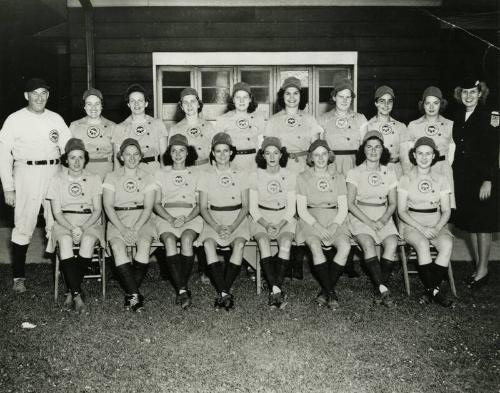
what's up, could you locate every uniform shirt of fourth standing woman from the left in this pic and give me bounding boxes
[214,110,267,150]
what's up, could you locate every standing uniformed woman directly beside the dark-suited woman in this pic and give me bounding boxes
[401,86,456,209]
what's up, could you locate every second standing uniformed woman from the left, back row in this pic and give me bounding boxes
[112,84,168,175]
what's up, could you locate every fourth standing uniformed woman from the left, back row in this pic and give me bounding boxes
[215,82,267,171]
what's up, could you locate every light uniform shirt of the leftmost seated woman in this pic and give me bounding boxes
[46,168,102,211]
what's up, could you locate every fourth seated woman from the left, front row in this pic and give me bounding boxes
[198,132,250,310]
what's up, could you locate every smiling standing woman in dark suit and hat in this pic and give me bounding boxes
[453,77,500,289]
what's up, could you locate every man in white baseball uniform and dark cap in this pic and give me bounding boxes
[0,78,71,293]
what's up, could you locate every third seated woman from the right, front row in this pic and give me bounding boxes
[295,140,351,309]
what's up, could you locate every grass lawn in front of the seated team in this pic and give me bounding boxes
[0,263,500,393]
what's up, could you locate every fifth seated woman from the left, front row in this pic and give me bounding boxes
[250,136,296,308]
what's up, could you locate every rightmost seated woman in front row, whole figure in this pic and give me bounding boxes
[398,137,453,307]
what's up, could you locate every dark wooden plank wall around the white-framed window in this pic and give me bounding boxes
[69,7,440,121]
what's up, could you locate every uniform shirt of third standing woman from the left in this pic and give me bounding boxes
[169,117,215,160]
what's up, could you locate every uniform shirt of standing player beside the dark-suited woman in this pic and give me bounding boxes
[402,115,453,158]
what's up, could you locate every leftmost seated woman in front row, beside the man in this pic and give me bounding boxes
[47,138,104,314]
